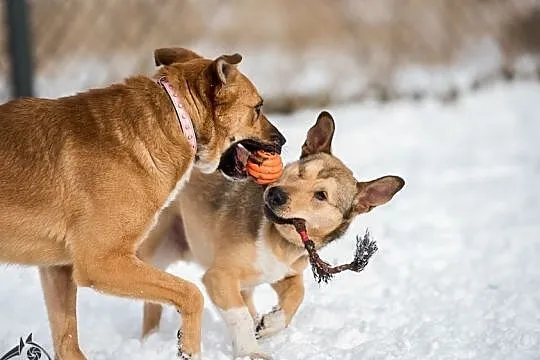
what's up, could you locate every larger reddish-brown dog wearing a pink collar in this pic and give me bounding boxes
[0,48,285,360]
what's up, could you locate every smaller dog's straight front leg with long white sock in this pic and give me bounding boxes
[203,267,270,359]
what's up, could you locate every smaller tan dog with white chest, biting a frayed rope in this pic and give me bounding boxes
[140,112,404,358]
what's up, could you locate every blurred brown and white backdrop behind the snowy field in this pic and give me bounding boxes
[0,0,540,112]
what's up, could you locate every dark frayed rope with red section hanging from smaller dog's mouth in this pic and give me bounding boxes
[292,219,378,284]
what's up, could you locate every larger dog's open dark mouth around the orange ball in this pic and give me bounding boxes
[218,139,281,179]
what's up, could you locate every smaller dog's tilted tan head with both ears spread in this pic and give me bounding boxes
[264,112,405,247]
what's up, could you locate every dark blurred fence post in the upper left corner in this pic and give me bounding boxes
[5,0,34,97]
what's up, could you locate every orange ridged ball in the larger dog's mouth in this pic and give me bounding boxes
[237,144,283,185]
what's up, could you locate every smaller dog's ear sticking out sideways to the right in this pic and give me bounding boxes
[353,176,405,214]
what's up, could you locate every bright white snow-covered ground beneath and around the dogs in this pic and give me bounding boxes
[0,83,540,360]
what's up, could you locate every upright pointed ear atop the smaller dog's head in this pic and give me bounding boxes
[300,111,335,159]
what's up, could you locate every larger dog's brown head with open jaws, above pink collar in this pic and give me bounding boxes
[154,48,285,178]
